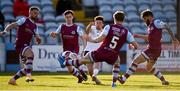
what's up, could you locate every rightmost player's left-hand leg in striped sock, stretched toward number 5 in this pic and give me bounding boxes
[119,54,146,84]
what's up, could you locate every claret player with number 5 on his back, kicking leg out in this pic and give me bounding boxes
[59,11,137,86]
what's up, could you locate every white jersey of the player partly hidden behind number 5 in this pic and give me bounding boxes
[84,26,102,51]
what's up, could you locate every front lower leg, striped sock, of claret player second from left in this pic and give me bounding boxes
[66,66,83,83]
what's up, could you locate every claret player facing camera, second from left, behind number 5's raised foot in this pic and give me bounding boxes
[50,10,87,83]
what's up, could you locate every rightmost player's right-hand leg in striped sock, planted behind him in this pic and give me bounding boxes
[146,60,169,85]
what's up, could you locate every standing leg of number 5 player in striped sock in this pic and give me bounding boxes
[112,57,120,87]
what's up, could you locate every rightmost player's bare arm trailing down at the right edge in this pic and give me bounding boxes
[165,24,180,49]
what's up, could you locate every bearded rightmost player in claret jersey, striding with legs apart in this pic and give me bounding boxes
[120,9,179,85]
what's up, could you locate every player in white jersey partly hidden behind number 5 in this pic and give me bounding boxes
[84,16,104,84]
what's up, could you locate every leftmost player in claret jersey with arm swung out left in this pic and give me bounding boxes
[0,6,41,85]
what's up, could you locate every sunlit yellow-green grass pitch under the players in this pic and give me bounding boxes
[0,72,180,91]
